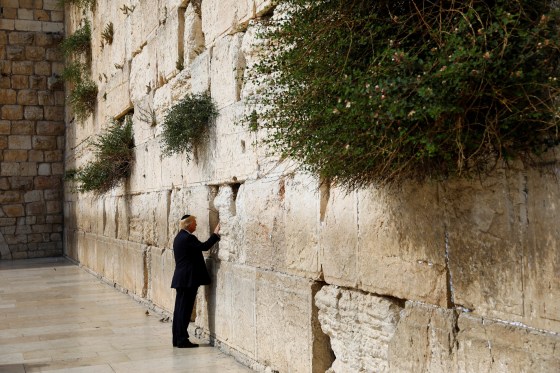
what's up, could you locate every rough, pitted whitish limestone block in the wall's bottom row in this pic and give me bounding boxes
[315,285,402,373]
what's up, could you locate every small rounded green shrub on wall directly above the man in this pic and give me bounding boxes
[160,93,218,161]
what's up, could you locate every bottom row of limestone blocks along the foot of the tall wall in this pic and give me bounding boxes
[66,231,560,373]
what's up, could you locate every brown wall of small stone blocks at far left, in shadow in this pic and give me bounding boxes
[0,0,65,259]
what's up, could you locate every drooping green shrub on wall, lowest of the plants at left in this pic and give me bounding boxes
[65,116,134,194]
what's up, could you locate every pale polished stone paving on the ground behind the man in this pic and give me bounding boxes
[0,258,251,373]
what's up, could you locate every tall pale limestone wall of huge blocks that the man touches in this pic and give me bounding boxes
[64,0,560,372]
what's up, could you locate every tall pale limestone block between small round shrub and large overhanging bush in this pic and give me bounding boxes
[210,33,245,109]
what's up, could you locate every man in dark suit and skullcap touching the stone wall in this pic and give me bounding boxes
[171,215,220,348]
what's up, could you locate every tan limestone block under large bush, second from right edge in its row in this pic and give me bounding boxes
[443,171,527,319]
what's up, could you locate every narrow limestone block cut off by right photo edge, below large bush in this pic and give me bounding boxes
[518,170,560,333]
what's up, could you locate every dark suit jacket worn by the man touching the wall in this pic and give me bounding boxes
[171,230,220,289]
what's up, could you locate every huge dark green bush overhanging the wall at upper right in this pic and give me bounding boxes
[246,0,560,190]
